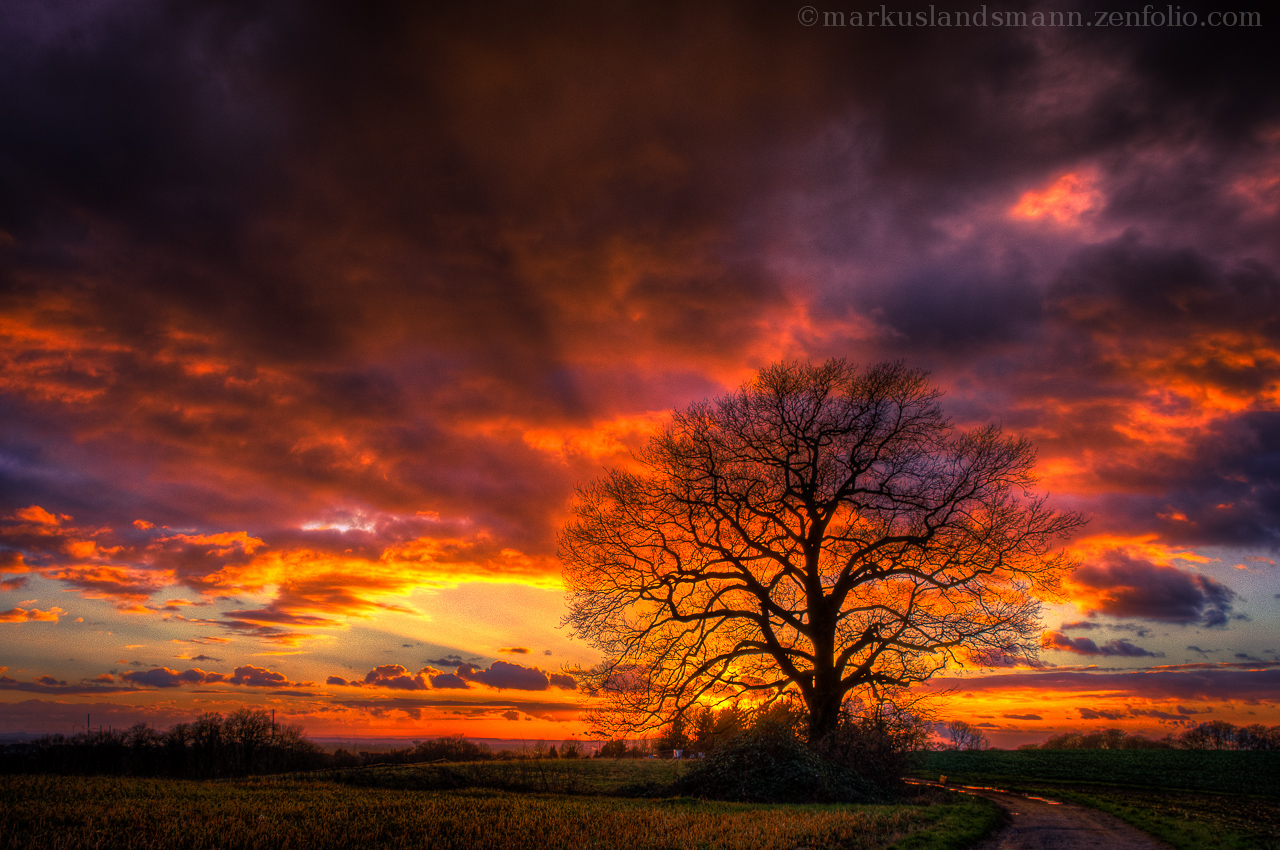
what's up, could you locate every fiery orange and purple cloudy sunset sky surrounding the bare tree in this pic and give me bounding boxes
[0,0,1280,745]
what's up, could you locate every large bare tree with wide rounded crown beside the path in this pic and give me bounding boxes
[561,360,1082,741]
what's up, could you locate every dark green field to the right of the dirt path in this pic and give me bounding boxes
[913,750,1280,850]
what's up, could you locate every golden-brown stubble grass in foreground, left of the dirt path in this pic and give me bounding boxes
[0,776,998,850]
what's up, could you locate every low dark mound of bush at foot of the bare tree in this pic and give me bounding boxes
[663,726,891,803]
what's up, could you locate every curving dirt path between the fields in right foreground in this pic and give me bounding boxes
[955,789,1169,850]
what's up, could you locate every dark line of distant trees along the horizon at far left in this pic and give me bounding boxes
[0,708,329,778]
